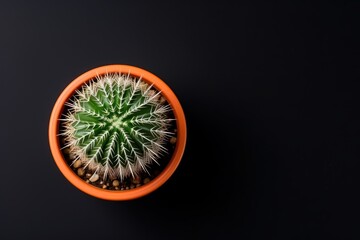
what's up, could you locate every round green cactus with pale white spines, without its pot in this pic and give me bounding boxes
[60,73,174,180]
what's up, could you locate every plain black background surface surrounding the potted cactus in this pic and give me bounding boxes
[0,1,360,240]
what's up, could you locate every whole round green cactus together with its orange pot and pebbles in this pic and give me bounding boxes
[49,65,186,200]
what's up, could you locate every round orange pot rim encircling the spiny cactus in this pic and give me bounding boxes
[49,65,186,201]
